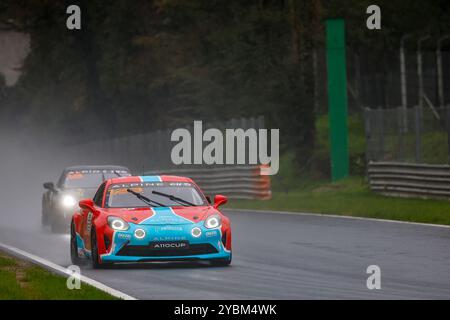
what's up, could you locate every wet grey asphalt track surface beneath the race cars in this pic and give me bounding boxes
[0,210,450,299]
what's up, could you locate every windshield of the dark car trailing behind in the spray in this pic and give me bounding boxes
[63,170,130,189]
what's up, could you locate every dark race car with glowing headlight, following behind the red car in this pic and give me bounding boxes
[41,166,131,232]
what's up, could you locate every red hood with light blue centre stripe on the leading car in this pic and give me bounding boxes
[104,206,218,225]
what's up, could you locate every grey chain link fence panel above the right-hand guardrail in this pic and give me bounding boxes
[364,106,450,164]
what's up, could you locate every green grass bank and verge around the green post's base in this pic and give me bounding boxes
[239,115,450,225]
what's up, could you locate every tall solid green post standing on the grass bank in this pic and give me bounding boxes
[326,19,348,181]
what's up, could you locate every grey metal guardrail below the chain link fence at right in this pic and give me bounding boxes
[368,162,450,200]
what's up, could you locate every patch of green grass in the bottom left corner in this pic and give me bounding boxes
[0,252,115,300]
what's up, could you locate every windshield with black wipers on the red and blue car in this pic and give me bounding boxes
[106,182,206,208]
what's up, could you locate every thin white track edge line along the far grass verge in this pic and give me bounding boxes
[224,208,450,229]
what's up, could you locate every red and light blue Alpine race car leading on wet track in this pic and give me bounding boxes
[70,176,231,268]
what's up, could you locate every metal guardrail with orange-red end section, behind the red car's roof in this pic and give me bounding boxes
[145,166,272,199]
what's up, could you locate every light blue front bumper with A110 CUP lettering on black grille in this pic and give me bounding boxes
[100,222,231,263]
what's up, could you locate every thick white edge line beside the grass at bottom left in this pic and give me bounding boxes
[0,243,137,300]
